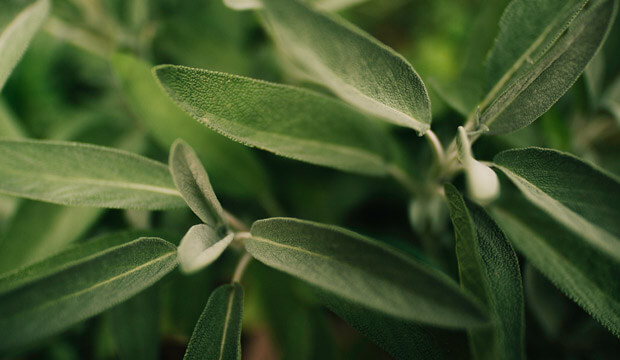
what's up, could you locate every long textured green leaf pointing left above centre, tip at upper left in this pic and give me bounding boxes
[155,65,398,175]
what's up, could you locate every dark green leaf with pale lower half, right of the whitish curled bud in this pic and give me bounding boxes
[494,148,620,260]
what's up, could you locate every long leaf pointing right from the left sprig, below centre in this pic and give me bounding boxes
[246,218,488,328]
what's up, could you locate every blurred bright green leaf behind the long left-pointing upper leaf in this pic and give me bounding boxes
[112,54,269,196]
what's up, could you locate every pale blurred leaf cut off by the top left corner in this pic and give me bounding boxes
[0,0,50,90]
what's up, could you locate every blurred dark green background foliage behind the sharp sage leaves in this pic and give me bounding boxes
[0,0,620,360]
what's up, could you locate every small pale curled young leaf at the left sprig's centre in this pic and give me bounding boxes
[178,224,235,273]
